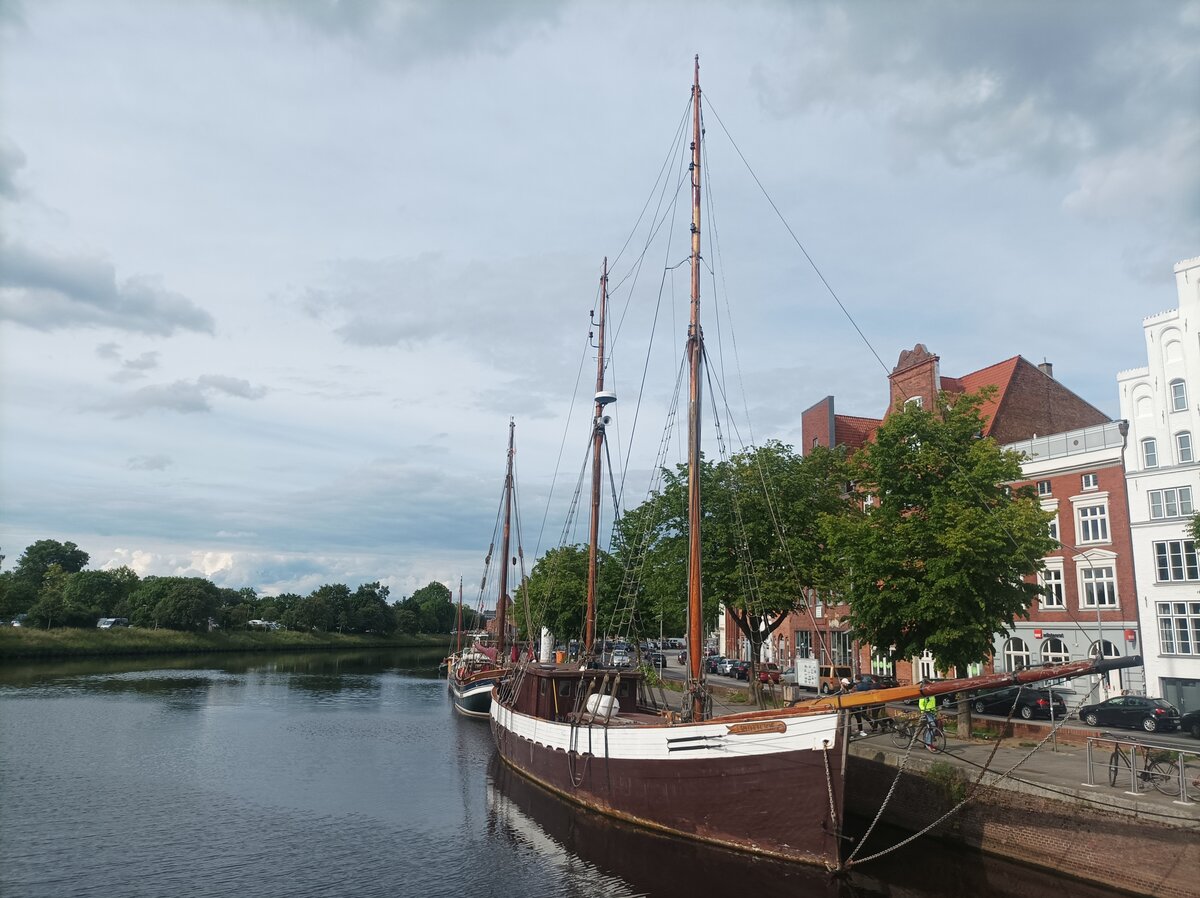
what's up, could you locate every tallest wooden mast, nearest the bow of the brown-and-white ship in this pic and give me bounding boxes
[688,55,704,720]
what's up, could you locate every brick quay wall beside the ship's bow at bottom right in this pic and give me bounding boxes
[846,747,1200,898]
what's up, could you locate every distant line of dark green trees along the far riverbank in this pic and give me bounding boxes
[0,547,482,635]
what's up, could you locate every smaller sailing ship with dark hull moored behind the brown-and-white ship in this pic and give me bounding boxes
[446,419,516,719]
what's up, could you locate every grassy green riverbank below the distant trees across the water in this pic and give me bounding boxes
[0,627,452,661]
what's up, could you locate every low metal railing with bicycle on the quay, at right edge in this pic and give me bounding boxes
[1085,732,1200,804]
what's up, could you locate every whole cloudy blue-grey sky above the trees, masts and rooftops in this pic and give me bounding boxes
[0,0,1200,598]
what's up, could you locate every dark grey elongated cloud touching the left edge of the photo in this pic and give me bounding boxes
[0,241,214,336]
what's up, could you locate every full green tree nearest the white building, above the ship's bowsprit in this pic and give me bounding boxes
[824,394,1056,725]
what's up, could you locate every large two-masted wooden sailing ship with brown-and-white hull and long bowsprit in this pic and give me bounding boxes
[491,58,1134,868]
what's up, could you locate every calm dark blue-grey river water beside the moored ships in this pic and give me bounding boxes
[0,651,1114,898]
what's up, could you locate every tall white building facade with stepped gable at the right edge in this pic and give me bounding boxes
[1117,258,1200,711]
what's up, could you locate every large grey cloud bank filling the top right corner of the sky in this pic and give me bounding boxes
[756,0,1200,221]
